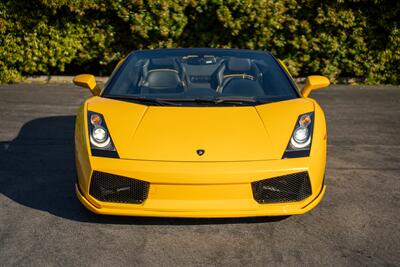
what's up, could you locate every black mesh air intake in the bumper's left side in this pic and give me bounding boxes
[89,171,149,204]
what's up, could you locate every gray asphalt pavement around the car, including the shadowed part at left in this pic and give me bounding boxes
[0,84,400,266]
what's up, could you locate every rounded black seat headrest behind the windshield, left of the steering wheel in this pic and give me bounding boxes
[144,69,180,89]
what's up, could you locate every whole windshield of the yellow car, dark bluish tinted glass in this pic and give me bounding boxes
[103,49,298,105]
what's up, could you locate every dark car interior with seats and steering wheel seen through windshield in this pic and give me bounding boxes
[113,55,290,98]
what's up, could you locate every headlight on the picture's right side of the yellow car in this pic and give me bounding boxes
[282,112,314,158]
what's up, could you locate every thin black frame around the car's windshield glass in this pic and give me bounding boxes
[99,48,301,106]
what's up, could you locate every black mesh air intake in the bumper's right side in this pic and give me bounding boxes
[251,172,311,203]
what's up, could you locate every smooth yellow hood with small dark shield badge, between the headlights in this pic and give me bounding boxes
[87,97,314,162]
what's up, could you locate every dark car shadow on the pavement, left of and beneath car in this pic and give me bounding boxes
[0,116,287,225]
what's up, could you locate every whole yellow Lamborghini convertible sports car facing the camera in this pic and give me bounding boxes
[74,48,329,217]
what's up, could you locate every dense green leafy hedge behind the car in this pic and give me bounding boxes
[0,0,400,84]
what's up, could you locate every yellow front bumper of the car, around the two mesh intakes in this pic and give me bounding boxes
[76,155,326,218]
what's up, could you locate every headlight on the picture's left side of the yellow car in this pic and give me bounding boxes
[88,111,119,158]
